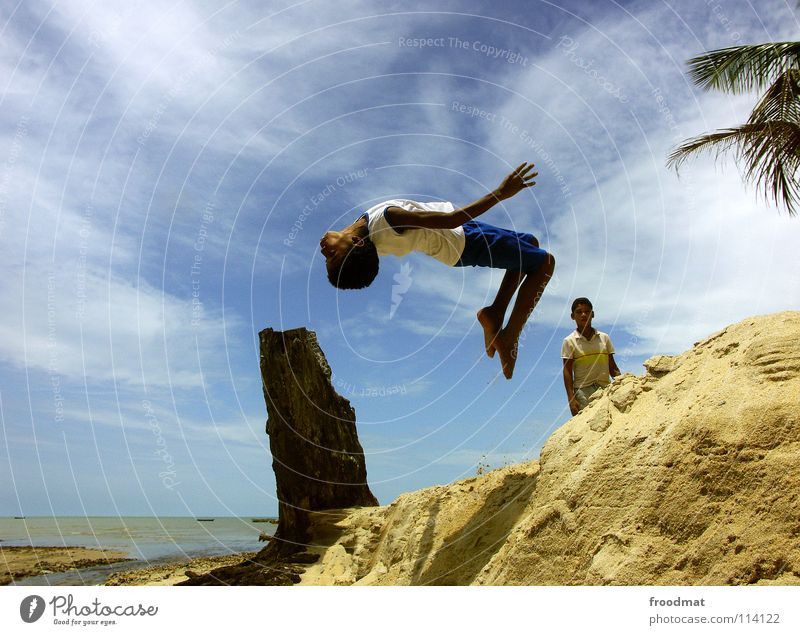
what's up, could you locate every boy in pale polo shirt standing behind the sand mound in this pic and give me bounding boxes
[561,298,620,415]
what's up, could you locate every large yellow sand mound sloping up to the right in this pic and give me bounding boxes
[302,312,800,585]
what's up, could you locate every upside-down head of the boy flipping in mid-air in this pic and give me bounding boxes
[319,228,379,289]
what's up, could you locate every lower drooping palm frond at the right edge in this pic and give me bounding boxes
[667,121,800,216]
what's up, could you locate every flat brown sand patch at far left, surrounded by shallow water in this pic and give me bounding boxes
[0,545,134,586]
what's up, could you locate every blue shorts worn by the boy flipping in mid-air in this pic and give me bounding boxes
[453,220,547,273]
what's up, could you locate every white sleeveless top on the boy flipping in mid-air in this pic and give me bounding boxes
[367,199,464,267]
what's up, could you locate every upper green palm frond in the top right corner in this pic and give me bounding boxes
[689,42,800,93]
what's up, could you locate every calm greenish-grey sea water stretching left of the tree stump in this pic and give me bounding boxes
[0,516,276,585]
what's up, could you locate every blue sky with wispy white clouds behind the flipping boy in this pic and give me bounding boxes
[0,0,800,515]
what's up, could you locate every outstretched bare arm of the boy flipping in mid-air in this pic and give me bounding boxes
[386,161,539,231]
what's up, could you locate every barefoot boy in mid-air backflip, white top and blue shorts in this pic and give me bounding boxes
[319,162,555,379]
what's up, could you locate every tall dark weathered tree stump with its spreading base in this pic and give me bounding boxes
[181,328,378,585]
